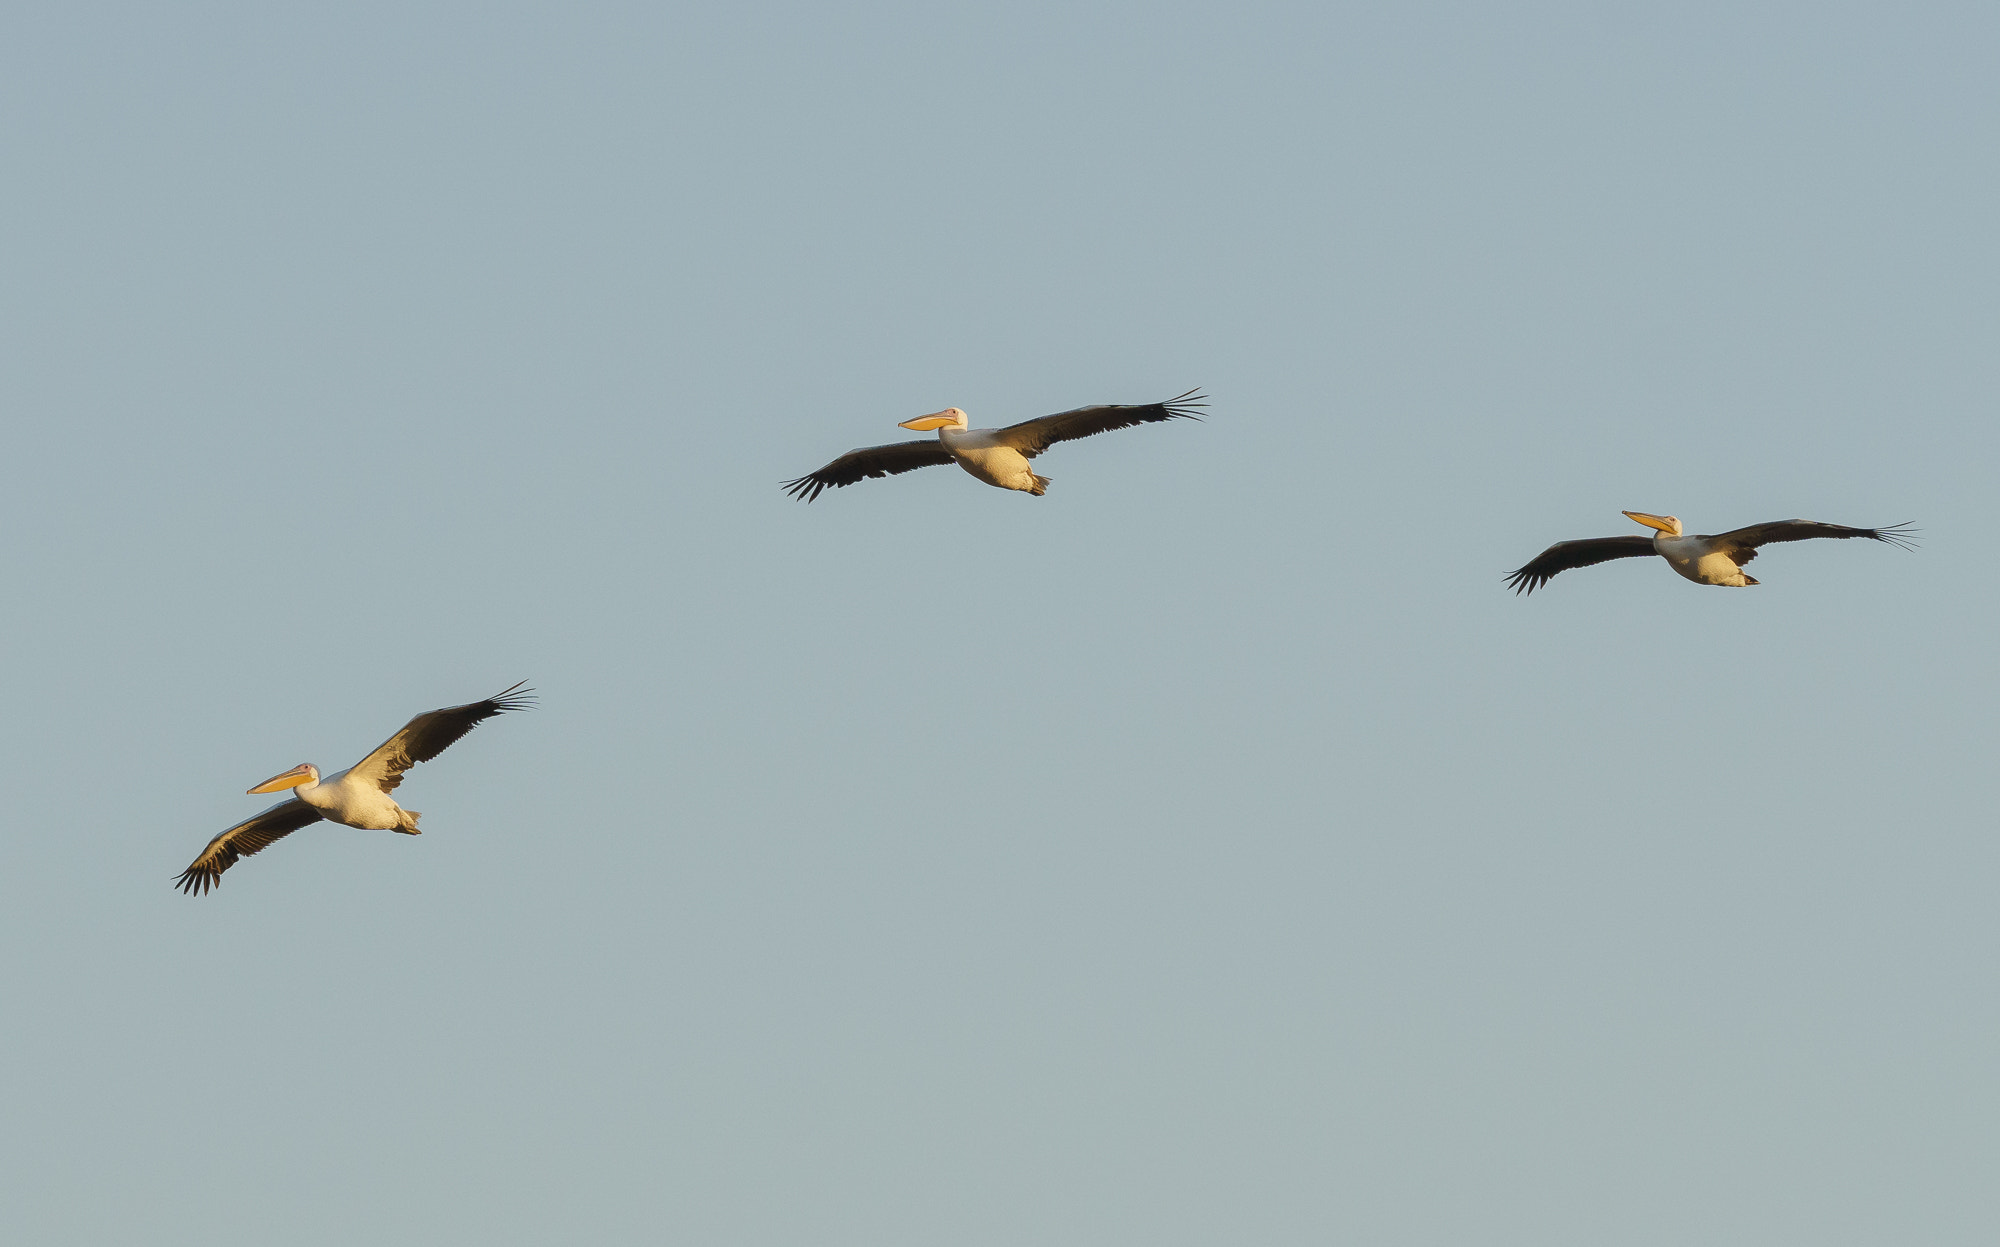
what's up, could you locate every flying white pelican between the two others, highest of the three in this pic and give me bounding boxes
[784,390,1208,502]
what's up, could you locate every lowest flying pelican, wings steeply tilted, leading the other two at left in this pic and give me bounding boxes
[176,679,534,895]
